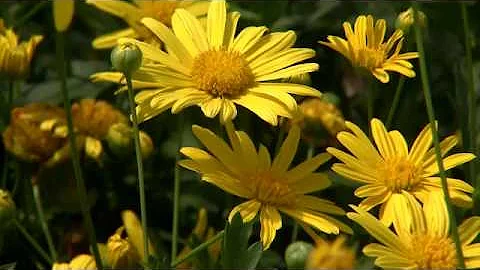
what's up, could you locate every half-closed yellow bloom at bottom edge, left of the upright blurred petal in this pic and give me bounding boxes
[107,226,140,269]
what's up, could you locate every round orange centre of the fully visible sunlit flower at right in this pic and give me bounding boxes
[379,157,422,192]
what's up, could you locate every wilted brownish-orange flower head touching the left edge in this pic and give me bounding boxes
[3,103,65,163]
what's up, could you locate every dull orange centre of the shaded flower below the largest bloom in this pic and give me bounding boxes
[250,172,295,206]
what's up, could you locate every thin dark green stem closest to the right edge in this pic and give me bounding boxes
[460,2,478,189]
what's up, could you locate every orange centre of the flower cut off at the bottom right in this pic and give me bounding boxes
[410,234,457,269]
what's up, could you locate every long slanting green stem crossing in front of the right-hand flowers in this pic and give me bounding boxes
[412,1,465,269]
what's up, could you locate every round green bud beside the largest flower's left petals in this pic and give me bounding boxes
[110,43,143,76]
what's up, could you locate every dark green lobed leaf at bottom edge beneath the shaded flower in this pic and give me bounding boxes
[221,213,263,269]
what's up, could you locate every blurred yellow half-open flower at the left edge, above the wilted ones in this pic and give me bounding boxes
[0,19,43,79]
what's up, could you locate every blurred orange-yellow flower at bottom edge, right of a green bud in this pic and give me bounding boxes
[305,236,356,269]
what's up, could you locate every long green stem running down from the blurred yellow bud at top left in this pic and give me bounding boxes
[56,32,103,270]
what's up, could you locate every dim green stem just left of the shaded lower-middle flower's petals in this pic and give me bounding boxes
[170,115,183,262]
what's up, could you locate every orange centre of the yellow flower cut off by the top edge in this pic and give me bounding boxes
[137,1,179,27]
